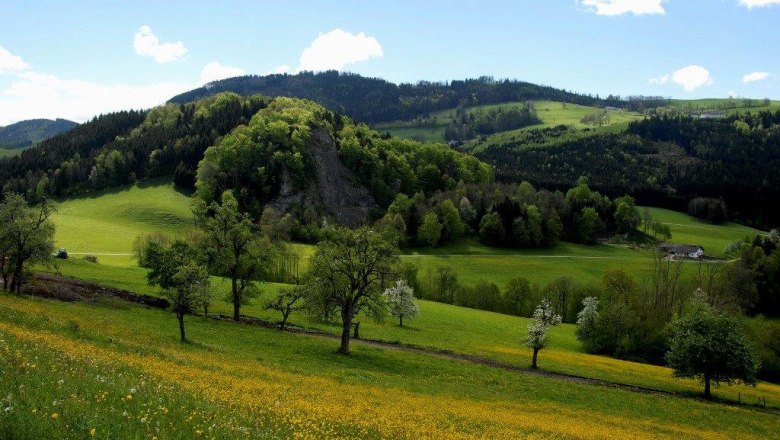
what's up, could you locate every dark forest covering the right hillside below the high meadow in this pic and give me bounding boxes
[474,112,780,228]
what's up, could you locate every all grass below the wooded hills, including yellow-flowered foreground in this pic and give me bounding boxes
[10,182,780,438]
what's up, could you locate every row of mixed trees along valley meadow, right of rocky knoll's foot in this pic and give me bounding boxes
[378,178,641,248]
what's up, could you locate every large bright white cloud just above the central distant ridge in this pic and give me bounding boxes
[298,29,384,71]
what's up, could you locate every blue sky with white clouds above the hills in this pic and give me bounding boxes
[0,0,780,125]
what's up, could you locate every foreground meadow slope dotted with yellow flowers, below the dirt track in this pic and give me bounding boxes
[0,294,780,439]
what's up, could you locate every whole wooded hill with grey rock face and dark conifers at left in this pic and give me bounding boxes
[0,93,493,225]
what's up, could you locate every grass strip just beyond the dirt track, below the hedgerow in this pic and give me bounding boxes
[50,260,780,408]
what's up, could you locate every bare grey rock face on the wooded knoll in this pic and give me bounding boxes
[271,129,377,227]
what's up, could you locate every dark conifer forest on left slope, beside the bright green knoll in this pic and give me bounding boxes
[0,94,268,201]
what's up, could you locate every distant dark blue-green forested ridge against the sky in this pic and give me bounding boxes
[170,71,665,123]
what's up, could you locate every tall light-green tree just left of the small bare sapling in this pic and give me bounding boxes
[193,191,271,321]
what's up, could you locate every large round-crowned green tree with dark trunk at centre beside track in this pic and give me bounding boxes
[307,227,399,354]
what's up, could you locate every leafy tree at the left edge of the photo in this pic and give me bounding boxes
[0,193,57,293]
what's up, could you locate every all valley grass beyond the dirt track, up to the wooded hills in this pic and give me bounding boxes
[42,182,780,405]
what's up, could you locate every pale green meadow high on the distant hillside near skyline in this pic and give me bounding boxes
[375,101,641,142]
